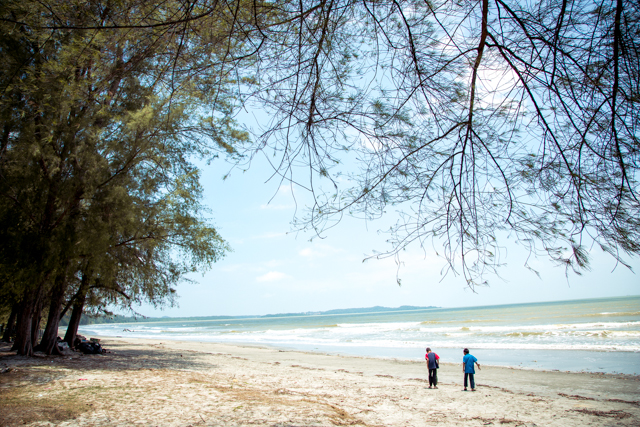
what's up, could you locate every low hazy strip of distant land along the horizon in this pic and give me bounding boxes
[67,305,440,326]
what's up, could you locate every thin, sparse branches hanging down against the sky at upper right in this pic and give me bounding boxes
[238,0,640,286]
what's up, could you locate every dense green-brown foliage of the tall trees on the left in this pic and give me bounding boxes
[0,0,247,346]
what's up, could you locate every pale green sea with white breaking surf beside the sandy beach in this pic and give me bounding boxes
[80,296,640,375]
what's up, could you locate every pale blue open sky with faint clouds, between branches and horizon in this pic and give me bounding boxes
[138,149,640,317]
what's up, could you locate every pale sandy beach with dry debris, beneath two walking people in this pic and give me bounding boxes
[0,338,640,427]
